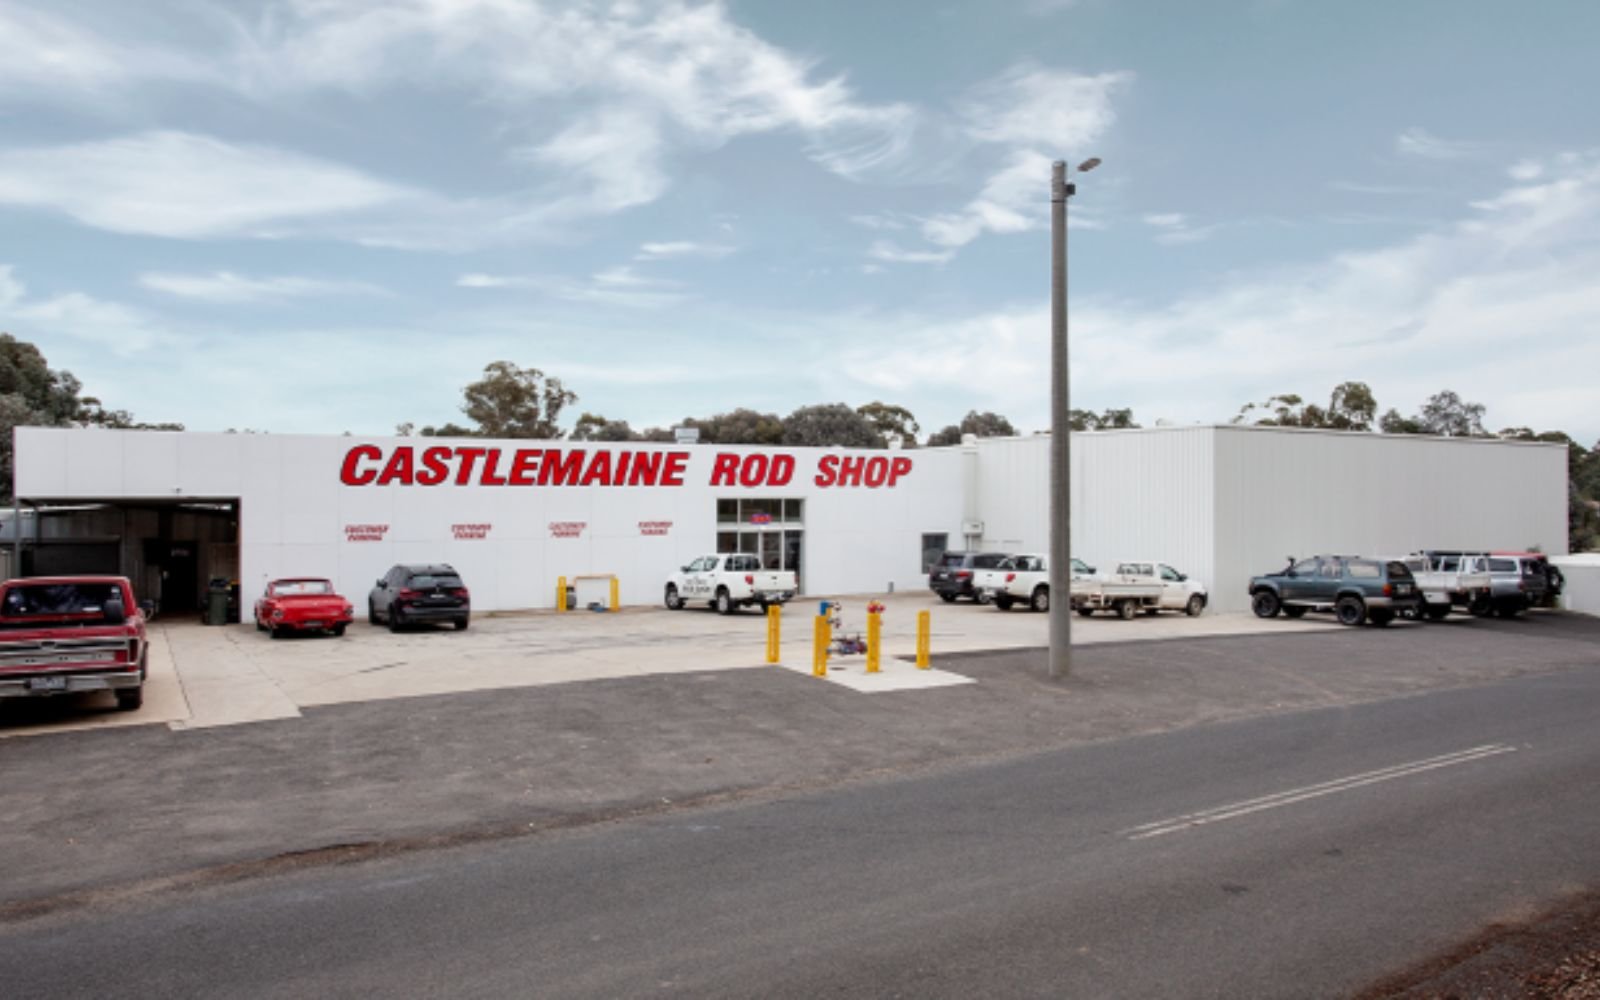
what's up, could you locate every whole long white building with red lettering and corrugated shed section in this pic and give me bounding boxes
[5,426,1566,611]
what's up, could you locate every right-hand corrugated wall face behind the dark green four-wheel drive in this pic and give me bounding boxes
[1213,427,1566,610]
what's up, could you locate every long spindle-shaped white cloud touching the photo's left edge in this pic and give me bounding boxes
[0,131,414,238]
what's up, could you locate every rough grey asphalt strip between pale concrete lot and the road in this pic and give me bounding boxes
[0,613,1600,920]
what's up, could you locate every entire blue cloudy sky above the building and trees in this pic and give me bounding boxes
[0,0,1600,443]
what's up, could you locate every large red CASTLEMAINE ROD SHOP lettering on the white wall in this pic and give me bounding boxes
[339,445,912,490]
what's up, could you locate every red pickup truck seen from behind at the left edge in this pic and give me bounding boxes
[0,576,149,712]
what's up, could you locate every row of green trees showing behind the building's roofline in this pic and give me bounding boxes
[0,333,1600,550]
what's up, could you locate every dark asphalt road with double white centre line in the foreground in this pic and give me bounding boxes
[9,667,1600,998]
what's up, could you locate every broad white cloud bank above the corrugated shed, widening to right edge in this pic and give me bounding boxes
[829,157,1600,440]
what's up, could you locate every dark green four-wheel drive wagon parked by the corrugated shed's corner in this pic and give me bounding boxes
[1250,555,1422,626]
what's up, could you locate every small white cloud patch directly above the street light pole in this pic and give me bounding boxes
[960,66,1133,148]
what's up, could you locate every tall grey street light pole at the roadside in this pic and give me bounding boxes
[1050,158,1099,680]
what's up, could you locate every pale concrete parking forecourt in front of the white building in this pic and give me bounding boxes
[0,594,1337,738]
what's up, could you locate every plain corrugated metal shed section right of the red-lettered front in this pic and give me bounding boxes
[978,426,1566,611]
